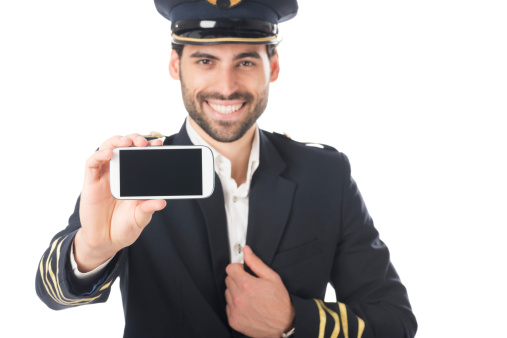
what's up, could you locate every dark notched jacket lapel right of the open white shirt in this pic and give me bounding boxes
[246,132,296,265]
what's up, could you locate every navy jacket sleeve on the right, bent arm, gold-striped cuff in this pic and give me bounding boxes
[292,155,417,338]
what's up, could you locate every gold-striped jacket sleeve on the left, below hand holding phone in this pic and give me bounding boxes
[35,199,124,310]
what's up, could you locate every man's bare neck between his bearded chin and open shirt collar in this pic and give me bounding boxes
[188,116,256,186]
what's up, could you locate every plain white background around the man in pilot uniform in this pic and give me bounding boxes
[0,0,507,337]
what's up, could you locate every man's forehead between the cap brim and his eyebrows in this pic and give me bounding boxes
[182,44,267,59]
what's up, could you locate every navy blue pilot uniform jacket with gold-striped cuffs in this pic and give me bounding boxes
[36,127,417,338]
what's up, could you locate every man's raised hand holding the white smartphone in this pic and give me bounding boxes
[74,134,166,272]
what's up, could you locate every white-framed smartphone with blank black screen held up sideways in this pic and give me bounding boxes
[110,146,215,200]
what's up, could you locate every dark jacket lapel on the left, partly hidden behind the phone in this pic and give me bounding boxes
[164,124,231,309]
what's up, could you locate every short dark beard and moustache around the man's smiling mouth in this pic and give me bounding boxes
[180,72,269,142]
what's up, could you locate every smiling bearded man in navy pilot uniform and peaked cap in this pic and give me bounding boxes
[36,0,417,338]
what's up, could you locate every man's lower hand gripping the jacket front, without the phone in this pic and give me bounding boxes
[225,246,295,338]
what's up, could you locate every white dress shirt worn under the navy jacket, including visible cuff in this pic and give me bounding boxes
[70,118,260,279]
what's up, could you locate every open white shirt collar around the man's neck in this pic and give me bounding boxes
[185,118,260,185]
